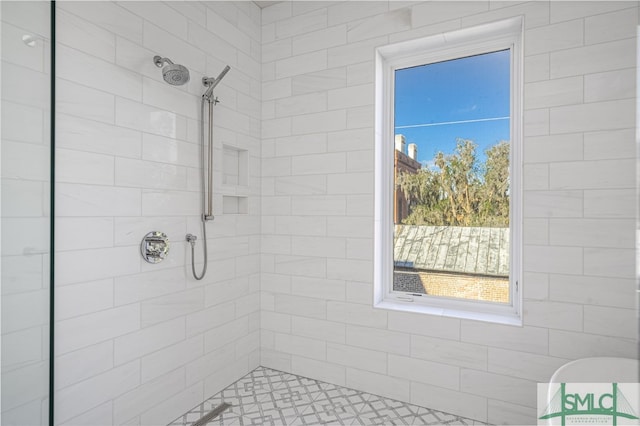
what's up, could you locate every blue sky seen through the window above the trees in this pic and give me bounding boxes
[395,50,510,163]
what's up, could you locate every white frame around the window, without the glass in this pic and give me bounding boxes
[373,17,524,325]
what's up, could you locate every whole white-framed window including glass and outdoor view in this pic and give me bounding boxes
[374,18,522,324]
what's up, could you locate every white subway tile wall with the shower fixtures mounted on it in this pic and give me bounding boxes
[53,1,260,425]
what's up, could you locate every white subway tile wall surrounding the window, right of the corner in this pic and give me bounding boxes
[261,1,638,424]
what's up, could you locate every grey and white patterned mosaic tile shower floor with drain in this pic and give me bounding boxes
[169,367,486,426]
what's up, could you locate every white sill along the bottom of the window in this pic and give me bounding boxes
[373,300,522,326]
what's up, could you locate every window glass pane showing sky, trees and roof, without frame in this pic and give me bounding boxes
[393,50,511,303]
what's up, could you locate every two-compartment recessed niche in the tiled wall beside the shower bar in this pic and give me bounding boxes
[222,145,249,214]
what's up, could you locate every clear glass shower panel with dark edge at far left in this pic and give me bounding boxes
[0,1,51,426]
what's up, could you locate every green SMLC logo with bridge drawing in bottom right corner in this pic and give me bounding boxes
[538,383,638,426]
